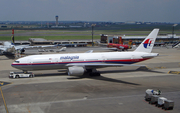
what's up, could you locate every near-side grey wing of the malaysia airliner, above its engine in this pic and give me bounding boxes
[66,63,144,68]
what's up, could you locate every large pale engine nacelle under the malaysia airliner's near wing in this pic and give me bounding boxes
[68,66,85,76]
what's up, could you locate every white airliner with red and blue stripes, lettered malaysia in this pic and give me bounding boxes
[11,29,159,76]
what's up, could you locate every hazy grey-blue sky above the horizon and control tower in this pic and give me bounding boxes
[0,0,180,23]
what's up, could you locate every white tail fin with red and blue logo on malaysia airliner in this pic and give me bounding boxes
[134,29,159,53]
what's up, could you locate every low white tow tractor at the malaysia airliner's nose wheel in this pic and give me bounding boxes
[9,72,34,78]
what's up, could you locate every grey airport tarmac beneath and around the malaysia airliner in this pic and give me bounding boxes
[0,47,180,113]
